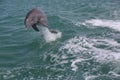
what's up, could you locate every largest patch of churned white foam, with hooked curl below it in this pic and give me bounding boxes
[60,37,120,71]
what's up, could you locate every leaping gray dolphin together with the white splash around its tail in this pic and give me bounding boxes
[24,8,61,42]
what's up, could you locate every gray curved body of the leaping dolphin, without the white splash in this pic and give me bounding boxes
[24,8,48,31]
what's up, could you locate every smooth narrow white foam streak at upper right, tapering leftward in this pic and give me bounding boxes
[75,19,120,31]
